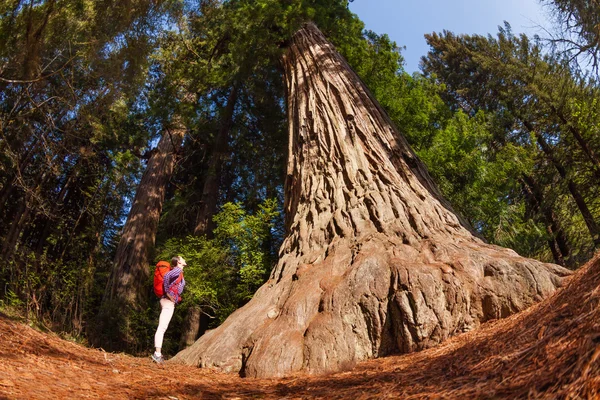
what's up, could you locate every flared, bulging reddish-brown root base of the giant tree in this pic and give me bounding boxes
[173,234,571,377]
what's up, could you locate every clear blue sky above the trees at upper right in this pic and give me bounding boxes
[350,0,550,73]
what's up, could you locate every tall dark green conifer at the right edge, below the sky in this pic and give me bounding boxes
[423,27,600,264]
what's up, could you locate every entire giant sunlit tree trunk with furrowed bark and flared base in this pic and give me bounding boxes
[173,24,569,377]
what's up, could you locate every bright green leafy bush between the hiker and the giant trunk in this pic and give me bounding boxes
[157,200,279,323]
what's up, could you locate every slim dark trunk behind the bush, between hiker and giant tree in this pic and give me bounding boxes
[179,84,239,349]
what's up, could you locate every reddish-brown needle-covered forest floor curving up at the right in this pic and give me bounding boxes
[0,256,600,400]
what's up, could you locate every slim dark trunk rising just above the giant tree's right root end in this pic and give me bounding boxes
[521,175,571,266]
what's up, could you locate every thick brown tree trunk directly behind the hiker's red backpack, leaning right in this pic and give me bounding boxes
[93,120,185,351]
